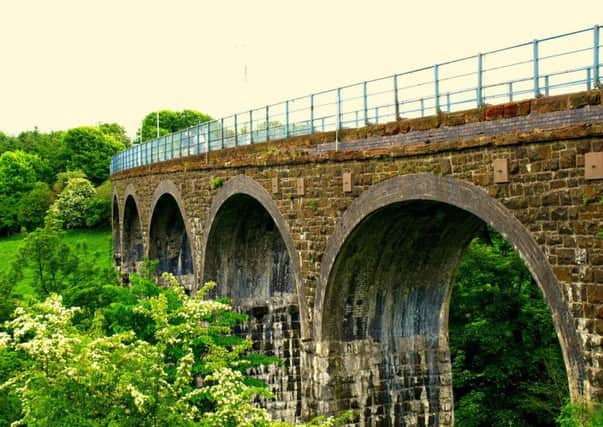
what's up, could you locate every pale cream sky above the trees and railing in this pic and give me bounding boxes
[0,0,603,135]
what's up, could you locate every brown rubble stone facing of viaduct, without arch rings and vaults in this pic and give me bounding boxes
[112,90,603,425]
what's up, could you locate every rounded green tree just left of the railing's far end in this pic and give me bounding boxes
[62,127,125,185]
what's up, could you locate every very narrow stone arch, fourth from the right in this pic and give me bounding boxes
[120,184,144,273]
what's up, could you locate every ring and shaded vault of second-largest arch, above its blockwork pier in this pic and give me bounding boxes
[201,175,308,336]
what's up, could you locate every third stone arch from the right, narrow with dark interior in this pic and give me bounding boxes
[147,181,195,289]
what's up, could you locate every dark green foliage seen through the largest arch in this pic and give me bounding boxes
[449,233,568,427]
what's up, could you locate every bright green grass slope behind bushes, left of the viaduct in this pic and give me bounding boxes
[0,230,113,295]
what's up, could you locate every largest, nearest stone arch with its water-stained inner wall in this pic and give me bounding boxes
[313,174,584,424]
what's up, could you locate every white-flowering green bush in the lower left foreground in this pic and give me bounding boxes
[0,275,352,427]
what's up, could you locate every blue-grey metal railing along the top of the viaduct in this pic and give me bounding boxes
[111,25,602,174]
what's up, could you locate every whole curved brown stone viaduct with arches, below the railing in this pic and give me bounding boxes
[112,90,603,426]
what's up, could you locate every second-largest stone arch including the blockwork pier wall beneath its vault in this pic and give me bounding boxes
[201,175,307,419]
